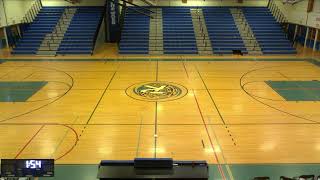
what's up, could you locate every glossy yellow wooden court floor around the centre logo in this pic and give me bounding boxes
[0,58,320,167]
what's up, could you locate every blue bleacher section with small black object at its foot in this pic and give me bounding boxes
[202,7,248,54]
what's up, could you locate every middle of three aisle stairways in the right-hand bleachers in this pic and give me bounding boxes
[190,8,213,55]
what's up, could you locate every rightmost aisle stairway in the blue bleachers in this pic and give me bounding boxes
[230,8,263,55]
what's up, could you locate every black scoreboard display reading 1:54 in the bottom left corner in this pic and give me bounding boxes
[0,159,54,177]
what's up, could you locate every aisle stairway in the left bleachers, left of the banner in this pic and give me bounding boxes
[37,8,77,56]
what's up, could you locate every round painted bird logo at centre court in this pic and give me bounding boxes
[127,82,188,101]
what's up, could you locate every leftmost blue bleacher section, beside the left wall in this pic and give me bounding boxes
[12,7,64,55]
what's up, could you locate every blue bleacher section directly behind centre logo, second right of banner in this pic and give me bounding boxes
[162,7,198,54]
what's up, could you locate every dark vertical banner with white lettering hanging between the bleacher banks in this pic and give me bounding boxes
[106,0,120,42]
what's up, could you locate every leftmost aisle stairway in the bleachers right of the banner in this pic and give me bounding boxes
[149,8,163,55]
